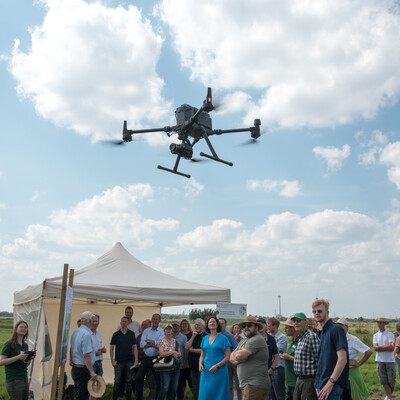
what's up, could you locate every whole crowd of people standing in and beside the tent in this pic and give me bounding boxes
[0,299,400,400]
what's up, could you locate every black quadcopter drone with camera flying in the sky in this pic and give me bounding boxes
[118,88,261,178]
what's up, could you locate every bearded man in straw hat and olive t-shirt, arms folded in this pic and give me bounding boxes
[230,315,270,400]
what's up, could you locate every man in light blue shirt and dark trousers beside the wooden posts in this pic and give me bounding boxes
[71,311,97,400]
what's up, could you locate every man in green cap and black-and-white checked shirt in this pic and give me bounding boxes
[292,313,319,400]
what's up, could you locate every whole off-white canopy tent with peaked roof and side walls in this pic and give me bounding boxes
[14,243,230,399]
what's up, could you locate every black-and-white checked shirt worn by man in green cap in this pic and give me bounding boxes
[294,329,319,375]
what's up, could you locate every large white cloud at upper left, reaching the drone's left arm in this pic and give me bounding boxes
[10,0,171,140]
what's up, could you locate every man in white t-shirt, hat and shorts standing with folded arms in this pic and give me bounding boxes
[373,318,396,400]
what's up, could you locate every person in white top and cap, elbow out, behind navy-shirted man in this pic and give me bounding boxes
[336,318,372,400]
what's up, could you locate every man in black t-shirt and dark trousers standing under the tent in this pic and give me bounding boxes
[110,316,139,400]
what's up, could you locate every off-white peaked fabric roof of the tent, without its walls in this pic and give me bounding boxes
[14,242,230,307]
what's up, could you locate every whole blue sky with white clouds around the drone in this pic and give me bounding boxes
[0,0,400,317]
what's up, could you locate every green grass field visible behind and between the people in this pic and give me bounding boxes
[0,318,400,400]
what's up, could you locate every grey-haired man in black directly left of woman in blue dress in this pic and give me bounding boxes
[185,318,206,400]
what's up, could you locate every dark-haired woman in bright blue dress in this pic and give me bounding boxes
[199,317,231,400]
